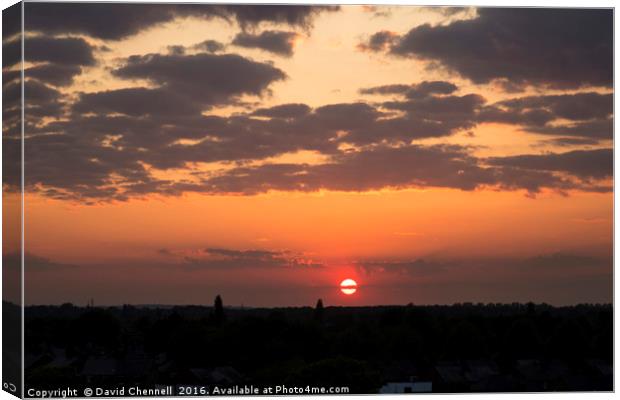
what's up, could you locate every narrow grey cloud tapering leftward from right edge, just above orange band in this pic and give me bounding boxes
[487,149,613,179]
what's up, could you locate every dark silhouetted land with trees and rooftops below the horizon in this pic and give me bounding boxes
[18,302,613,393]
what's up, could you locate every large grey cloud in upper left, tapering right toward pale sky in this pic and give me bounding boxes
[73,53,285,118]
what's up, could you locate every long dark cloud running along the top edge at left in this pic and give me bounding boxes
[25,3,338,40]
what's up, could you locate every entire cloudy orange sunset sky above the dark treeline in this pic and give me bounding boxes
[3,3,613,306]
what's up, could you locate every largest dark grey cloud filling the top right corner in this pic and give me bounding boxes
[372,8,613,88]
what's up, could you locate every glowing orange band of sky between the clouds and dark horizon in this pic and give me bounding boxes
[18,183,613,305]
